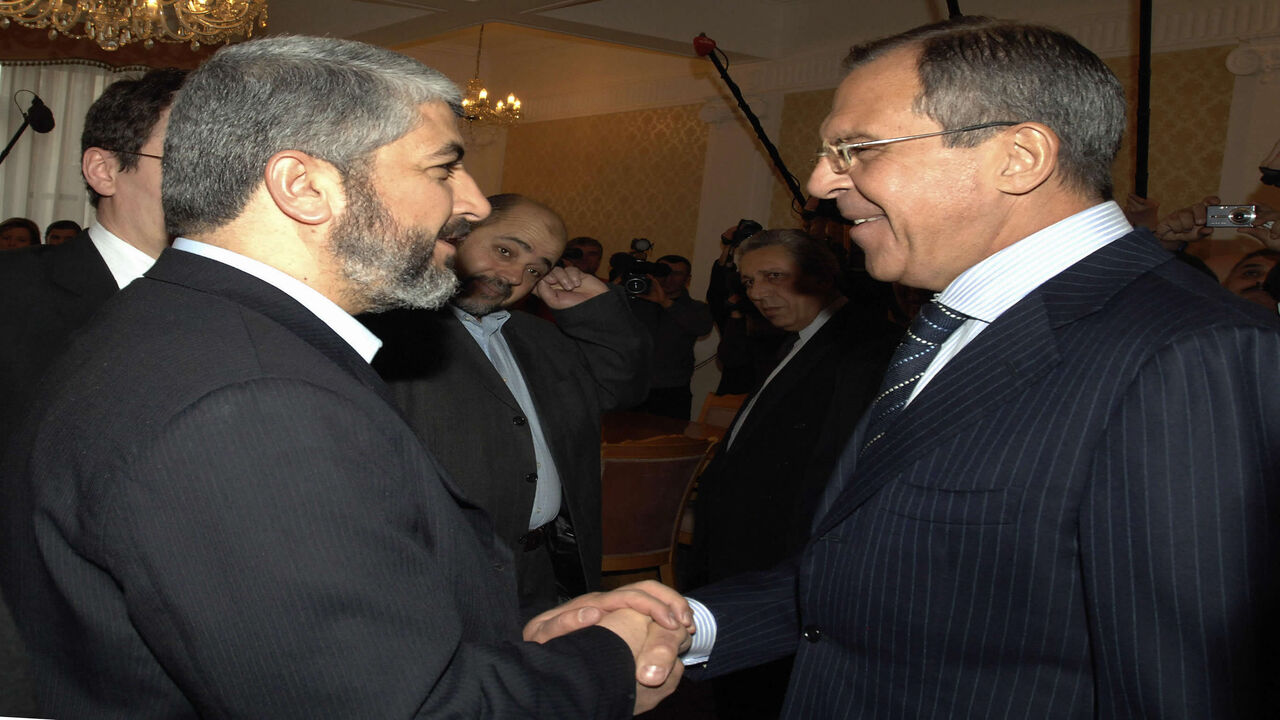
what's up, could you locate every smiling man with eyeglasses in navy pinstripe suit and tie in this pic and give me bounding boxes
[540,18,1280,720]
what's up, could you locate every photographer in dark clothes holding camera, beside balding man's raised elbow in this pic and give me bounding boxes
[622,254,712,420]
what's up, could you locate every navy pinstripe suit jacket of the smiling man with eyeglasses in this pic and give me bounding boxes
[692,233,1280,719]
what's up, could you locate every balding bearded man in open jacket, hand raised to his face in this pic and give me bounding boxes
[366,193,650,616]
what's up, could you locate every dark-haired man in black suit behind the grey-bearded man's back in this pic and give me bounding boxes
[0,64,187,715]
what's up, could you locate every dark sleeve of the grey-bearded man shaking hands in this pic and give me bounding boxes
[100,379,635,719]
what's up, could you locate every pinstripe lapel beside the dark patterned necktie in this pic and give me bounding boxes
[815,226,1171,534]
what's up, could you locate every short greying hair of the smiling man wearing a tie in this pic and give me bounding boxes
[845,17,1125,200]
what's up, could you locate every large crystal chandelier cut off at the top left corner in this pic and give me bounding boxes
[0,0,266,50]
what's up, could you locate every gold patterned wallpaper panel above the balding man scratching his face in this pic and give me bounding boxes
[502,105,708,263]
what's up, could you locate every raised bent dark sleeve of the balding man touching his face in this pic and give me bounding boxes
[554,286,653,411]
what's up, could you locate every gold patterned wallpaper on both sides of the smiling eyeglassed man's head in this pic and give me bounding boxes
[769,46,1234,233]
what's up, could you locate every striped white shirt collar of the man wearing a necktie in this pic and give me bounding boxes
[937,200,1133,323]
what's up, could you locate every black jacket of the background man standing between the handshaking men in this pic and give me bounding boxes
[694,302,901,580]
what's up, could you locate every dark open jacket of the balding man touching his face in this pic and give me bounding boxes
[364,291,649,599]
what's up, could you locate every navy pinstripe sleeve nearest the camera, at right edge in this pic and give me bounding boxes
[1079,328,1280,717]
